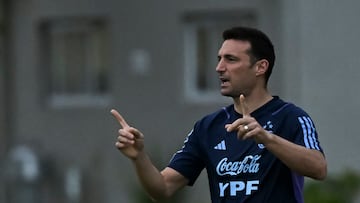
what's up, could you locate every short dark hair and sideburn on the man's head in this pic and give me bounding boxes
[223,27,275,83]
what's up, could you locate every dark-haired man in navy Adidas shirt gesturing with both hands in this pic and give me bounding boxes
[111,27,327,203]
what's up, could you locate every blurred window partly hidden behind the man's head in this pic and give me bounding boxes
[183,10,256,103]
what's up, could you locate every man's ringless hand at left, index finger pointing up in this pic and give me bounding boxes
[110,109,144,160]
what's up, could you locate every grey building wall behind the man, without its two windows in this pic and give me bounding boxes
[0,0,360,202]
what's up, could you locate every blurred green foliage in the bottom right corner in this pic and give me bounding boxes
[304,170,360,203]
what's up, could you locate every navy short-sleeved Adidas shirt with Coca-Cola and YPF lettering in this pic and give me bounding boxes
[168,96,323,203]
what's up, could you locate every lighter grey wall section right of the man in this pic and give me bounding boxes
[284,0,360,174]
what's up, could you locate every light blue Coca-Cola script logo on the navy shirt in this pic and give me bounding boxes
[216,155,261,176]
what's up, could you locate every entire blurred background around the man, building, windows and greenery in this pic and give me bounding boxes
[0,0,360,203]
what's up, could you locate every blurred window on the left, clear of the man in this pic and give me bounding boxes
[41,18,108,106]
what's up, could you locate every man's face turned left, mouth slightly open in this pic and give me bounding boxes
[216,39,256,97]
